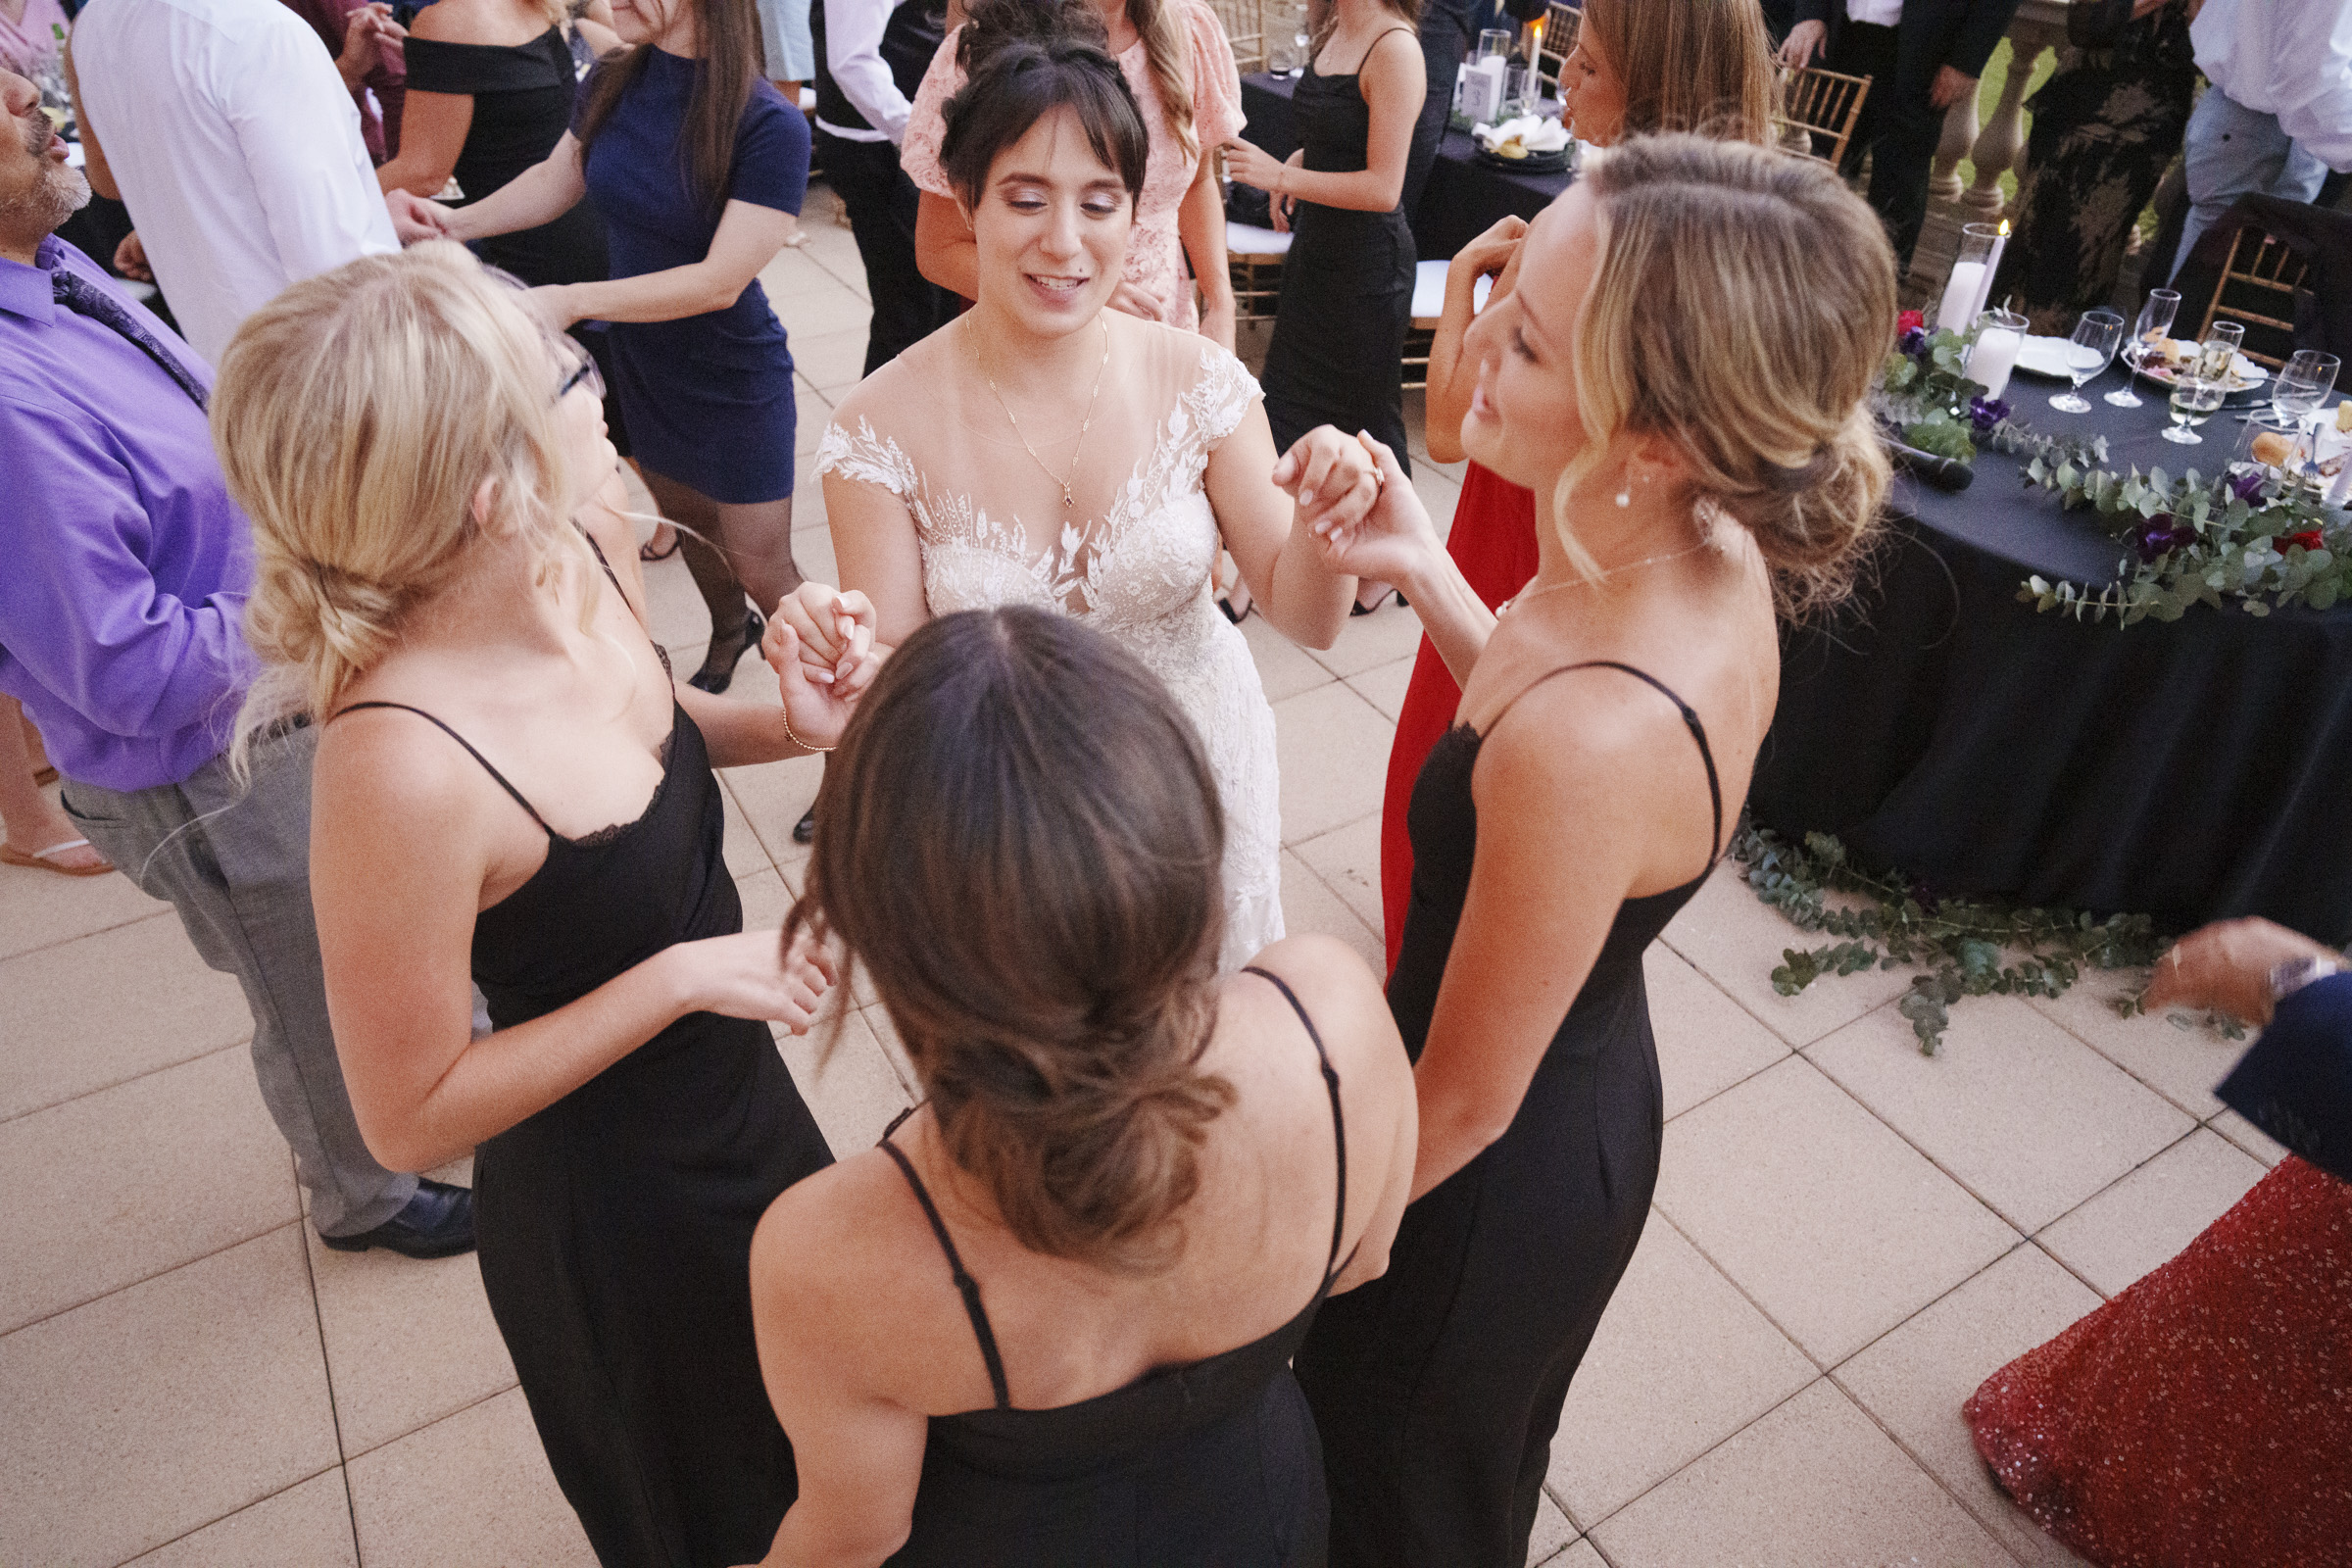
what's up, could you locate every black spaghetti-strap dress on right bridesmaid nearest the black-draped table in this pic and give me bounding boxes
[1296,661,1724,1568]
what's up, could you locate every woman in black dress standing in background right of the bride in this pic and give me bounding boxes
[1225,0,1428,479]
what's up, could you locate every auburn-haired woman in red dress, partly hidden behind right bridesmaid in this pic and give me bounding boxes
[1381,0,1771,964]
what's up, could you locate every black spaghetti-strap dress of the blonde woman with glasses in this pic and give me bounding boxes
[331,686,833,1568]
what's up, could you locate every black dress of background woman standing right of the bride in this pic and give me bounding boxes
[1258,28,1418,467]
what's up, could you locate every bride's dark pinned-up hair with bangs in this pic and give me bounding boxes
[939,0,1152,207]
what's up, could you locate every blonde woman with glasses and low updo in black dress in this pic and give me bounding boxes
[212,242,870,1568]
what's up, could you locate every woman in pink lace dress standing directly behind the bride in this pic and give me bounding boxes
[899,0,1242,353]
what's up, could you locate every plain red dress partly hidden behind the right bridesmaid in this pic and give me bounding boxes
[1381,464,1536,968]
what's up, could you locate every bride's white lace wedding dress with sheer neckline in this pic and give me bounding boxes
[816,326,1282,971]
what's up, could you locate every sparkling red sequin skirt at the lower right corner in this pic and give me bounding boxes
[1962,1156,2352,1568]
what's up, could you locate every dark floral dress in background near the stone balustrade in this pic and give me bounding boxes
[1992,0,2197,334]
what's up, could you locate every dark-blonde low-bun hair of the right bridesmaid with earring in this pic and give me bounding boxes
[1552,134,1895,613]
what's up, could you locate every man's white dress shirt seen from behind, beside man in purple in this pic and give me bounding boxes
[73,0,427,365]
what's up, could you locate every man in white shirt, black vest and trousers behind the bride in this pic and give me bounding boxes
[809,0,955,376]
